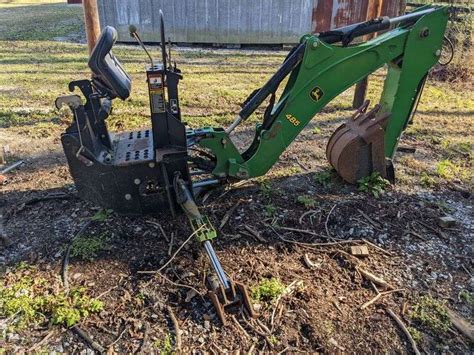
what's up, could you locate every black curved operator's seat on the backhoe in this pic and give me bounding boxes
[89,26,132,100]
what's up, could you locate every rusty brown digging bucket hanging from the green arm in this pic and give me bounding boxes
[326,101,390,184]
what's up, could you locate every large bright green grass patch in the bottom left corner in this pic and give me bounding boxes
[0,268,104,330]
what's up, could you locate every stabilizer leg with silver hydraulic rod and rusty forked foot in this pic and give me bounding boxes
[174,177,257,326]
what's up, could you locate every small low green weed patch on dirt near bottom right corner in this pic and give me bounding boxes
[410,296,451,333]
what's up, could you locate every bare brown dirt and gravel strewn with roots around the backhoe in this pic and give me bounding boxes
[1,117,474,353]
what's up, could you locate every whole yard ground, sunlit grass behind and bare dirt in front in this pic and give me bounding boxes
[0,1,474,354]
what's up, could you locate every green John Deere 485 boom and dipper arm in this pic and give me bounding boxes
[198,8,448,179]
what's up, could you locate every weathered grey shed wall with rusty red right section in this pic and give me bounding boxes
[98,0,404,44]
